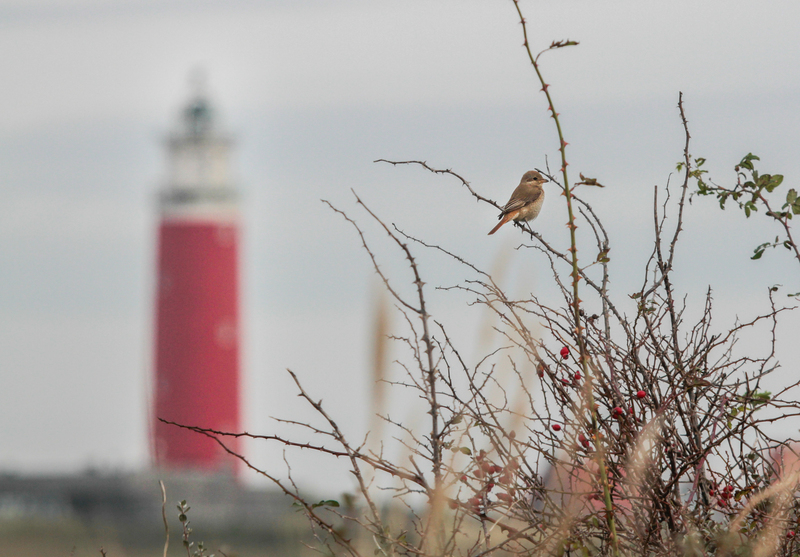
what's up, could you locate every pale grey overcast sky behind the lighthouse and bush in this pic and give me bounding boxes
[0,0,800,494]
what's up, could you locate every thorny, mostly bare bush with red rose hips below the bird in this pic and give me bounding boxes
[164,3,800,556]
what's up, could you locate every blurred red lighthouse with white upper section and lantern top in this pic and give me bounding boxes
[152,89,240,471]
